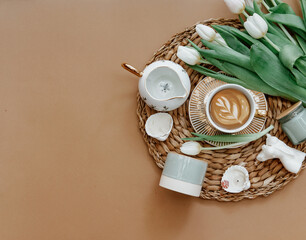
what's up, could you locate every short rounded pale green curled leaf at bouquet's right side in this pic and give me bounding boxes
[279,44,304,70]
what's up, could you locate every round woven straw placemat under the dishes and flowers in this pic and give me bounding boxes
[137,19,306,201]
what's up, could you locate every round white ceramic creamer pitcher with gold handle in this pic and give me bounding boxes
[122,60,190,111]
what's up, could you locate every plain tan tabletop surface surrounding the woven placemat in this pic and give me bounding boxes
[0,0,306,240]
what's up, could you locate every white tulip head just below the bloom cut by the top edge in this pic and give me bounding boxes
[244,13,268,39]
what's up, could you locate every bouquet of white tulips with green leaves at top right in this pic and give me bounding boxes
[177,0,306,105]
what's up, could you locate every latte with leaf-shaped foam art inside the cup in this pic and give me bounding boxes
[209,88,251,129]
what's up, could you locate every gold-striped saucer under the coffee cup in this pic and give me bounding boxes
[189,77,268,147]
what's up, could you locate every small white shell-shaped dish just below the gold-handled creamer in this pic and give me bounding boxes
[145,113,173,141]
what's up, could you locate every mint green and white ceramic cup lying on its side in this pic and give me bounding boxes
[159,152,208,197]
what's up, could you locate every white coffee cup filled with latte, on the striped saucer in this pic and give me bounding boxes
[204,84,265,133]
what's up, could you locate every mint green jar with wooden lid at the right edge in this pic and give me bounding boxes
[277,102,306,145]
